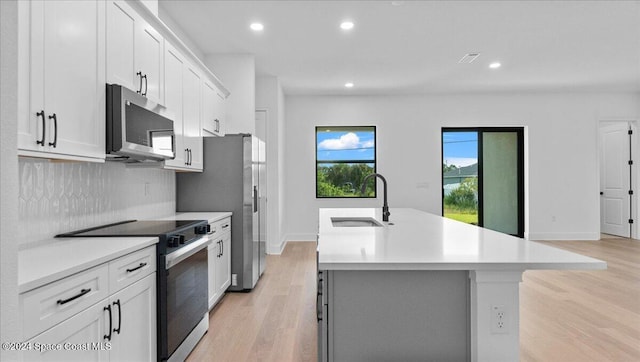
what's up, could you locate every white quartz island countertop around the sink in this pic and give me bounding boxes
[318,208,607,271]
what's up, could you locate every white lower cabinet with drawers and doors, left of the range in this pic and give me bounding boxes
[20,246,157,361]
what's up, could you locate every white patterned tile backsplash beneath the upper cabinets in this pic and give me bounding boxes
[18,158,176,248]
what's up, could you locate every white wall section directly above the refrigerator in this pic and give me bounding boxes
[204,54,256,134]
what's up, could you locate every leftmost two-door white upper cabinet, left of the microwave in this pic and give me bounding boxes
[18,1,106,162]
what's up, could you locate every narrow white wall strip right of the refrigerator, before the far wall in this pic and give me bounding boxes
[256,76,285,254]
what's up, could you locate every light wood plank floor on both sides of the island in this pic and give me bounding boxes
[188,238,640,362]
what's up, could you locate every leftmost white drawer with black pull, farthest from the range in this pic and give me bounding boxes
[20,264,109,339]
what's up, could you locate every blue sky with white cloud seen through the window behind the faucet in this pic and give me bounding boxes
[316,130,375,161]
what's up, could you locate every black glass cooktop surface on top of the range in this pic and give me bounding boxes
[56,220,202,237]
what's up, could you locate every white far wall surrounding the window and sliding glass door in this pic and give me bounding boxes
[285,93,640,240]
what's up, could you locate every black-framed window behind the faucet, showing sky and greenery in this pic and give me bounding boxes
[316,126,376,198]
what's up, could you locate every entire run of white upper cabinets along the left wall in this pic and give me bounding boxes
[17,0,229,164]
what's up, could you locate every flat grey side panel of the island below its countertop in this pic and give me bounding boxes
[327,270,471,361]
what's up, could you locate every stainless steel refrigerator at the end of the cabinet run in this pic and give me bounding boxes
[176,134,266,291]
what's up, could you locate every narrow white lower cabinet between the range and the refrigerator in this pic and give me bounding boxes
[207,218,231,309]
